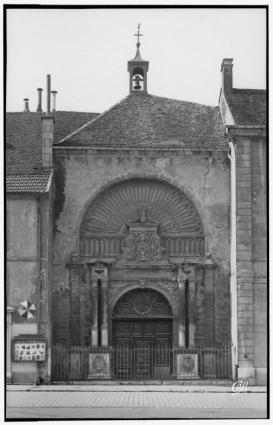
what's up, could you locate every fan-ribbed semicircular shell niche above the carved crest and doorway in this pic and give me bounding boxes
[76,178,205,261]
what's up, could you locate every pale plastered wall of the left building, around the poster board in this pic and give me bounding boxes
[6,195,52,382]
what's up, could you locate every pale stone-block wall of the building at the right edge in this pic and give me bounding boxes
[236,136,267,385]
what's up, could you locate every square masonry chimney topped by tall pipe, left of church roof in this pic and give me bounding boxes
[42,75,55,168]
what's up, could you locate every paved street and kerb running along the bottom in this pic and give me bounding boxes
[6,385,267,420]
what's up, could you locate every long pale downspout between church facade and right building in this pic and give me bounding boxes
[227,134,238,381]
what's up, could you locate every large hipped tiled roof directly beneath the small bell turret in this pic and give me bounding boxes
[59,94,228,150]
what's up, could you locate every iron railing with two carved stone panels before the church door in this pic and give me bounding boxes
[52,345,232,381]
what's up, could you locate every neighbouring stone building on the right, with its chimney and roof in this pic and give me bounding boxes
[219,59,268,385]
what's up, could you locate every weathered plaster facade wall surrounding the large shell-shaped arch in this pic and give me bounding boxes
[53,151,230,344]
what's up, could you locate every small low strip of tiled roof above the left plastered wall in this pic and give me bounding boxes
[6,171,51,193]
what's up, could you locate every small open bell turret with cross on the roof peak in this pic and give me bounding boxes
[128,24,149,94]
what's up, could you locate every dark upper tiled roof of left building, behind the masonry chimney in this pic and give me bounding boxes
[6,112,98,175]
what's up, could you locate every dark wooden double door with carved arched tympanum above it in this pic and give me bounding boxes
[112,288,173,379]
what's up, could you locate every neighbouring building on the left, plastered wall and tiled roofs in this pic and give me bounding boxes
[6,101,96,383]
